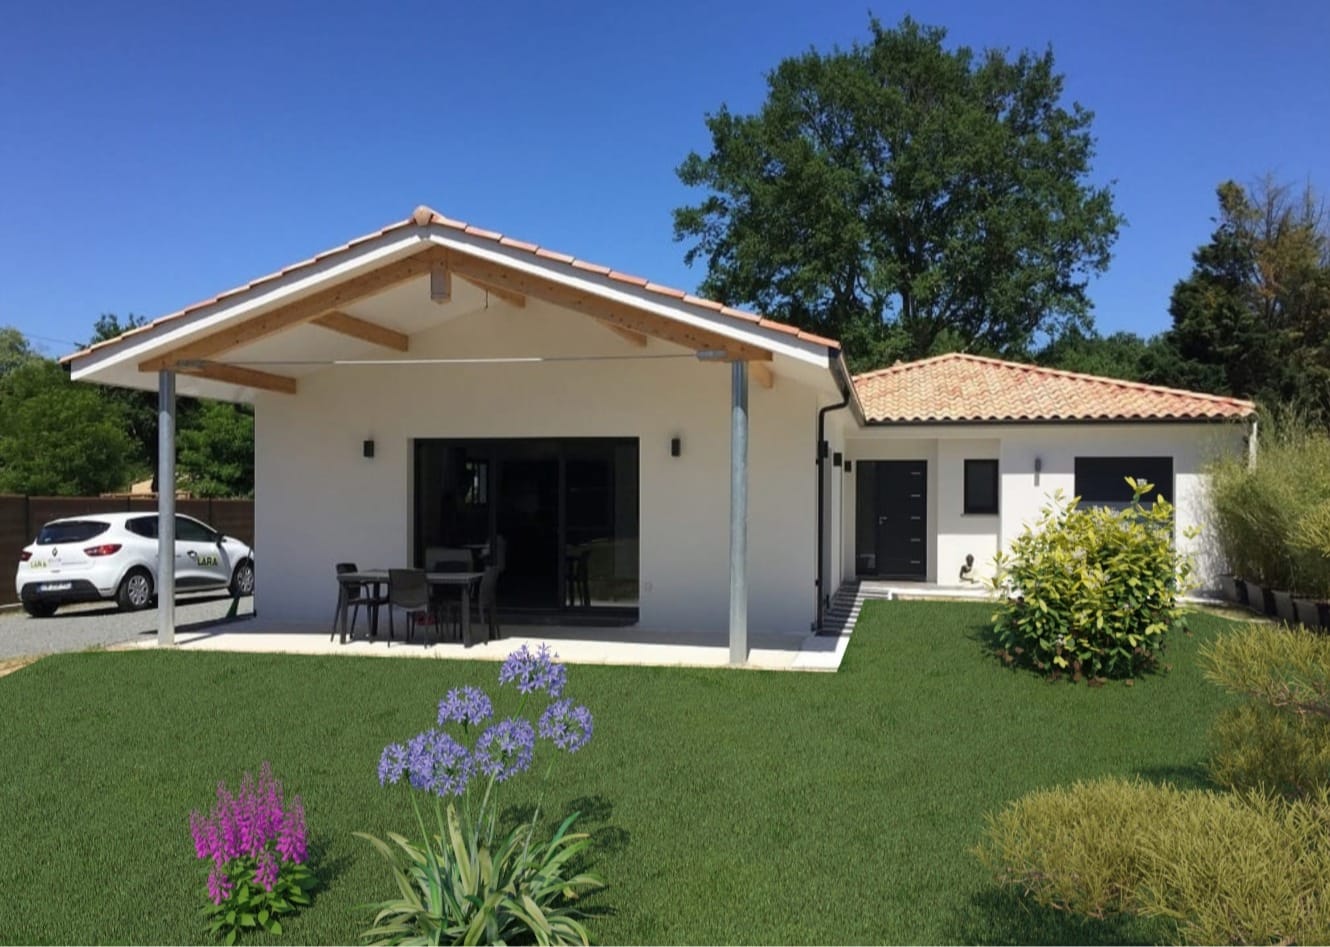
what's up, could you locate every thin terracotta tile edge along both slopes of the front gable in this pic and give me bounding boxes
[60,205,841,362]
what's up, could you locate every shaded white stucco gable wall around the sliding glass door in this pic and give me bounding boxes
[255,301,821,633]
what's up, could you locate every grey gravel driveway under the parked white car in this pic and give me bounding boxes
[0,593,254,658]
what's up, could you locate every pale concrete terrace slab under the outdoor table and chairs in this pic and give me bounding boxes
[111,618,849,672]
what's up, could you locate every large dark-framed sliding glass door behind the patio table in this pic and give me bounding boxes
[415,438,638,612]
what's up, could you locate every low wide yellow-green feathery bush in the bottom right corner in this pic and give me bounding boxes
[978,779,1330,944]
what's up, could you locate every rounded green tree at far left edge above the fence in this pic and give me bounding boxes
[0,358,134,496]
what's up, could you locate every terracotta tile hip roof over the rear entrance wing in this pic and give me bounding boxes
[854,352,1256,423]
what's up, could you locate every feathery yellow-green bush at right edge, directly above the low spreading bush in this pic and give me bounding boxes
[1201,624,1330,798]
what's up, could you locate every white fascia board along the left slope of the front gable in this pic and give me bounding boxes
[69,227,427,387]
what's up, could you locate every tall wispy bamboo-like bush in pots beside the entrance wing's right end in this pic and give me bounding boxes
[1206,423,1330,599]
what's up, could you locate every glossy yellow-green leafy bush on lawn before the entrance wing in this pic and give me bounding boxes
[994,477,1192,681]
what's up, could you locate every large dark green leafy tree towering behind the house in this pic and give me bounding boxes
[674,17,1121,367]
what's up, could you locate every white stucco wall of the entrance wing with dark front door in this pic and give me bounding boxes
[839,423,1246,589]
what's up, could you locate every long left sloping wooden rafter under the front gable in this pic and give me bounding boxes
[138,246,448,371]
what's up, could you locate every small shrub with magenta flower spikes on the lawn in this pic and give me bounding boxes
[189,762,317,944]
